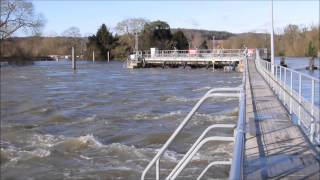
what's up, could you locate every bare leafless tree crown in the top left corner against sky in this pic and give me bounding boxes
[0,0,44,40]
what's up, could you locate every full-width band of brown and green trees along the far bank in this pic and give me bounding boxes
[0,18,319,60]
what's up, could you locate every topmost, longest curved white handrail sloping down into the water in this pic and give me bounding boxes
[141,88,241,180]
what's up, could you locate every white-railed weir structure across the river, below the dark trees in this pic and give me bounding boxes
[127,48,245,72]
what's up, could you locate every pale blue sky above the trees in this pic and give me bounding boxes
[28,0,319,36]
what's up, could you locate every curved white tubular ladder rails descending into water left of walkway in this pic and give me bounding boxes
[141,87,245,180]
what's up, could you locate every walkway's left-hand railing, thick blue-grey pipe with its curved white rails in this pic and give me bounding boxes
[141,58,247,180]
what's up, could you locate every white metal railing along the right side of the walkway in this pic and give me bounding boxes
[256,50,320,144]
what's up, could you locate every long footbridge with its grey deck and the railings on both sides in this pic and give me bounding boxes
[141,50,320,180]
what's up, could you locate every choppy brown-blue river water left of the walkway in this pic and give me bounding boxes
[0,61,241,179]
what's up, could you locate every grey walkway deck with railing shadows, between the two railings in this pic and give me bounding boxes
[244,60,320,180]
